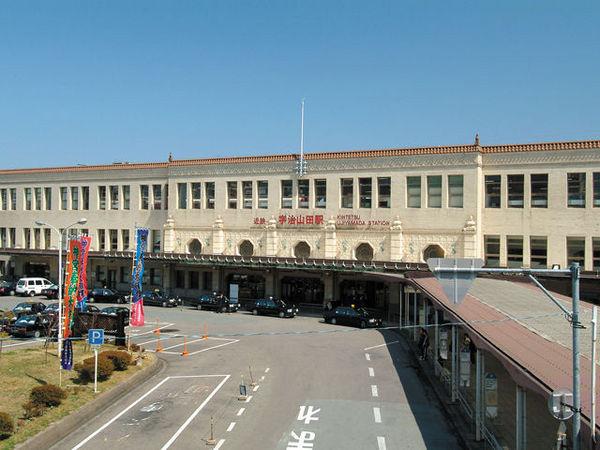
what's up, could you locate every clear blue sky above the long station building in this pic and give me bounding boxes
[0,0,600,168]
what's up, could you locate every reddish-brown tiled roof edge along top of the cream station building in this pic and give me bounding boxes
[0,140,600,175]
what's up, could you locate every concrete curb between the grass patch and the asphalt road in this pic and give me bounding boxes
[15,357,166,450]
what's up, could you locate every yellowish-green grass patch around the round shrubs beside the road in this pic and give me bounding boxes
[0,342,153,449]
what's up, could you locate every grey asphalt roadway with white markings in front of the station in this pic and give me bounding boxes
[0,297,460,450]
